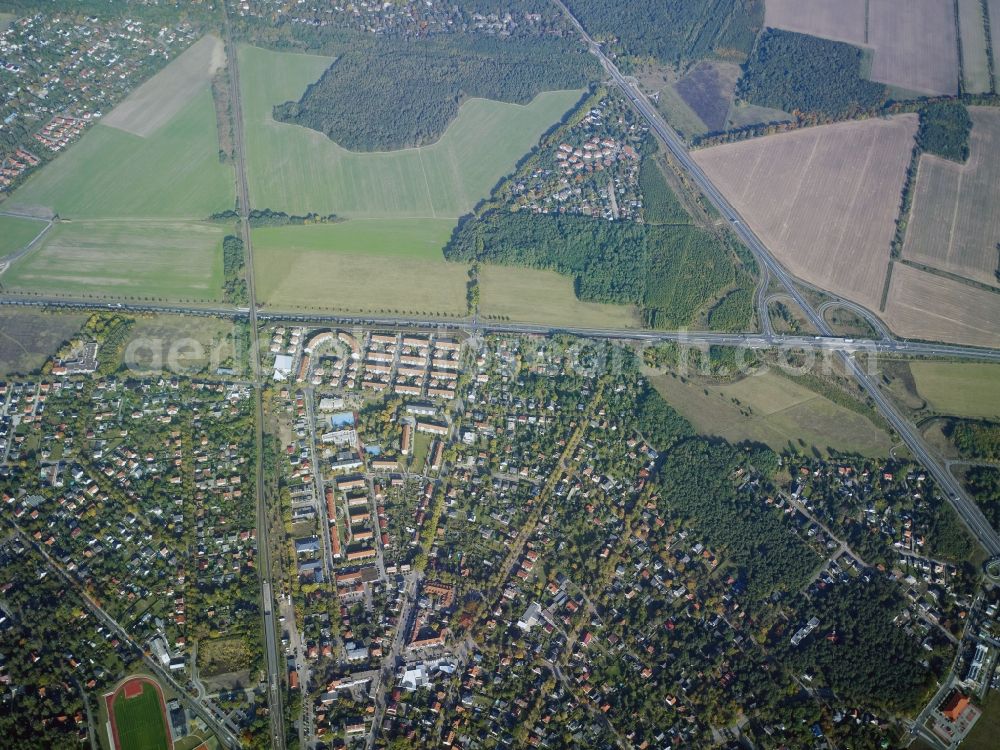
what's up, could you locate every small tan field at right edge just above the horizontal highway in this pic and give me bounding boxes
[883,263,1000,347]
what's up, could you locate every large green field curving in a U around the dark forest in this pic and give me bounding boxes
[239,47,582,218]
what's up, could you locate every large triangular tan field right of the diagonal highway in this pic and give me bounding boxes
[693,115,917,309]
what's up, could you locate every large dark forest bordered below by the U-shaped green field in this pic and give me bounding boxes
[274,34,599,151]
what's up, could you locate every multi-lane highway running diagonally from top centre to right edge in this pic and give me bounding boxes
[553,0,1000,556]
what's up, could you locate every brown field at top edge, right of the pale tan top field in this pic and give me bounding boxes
[868,0,958,94]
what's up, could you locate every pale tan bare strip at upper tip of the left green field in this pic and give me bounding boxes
[102,35,226,138]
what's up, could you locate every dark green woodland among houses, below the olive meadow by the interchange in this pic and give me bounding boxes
[657,438,820,600]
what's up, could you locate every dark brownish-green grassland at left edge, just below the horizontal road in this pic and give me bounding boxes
[0,306,87,376]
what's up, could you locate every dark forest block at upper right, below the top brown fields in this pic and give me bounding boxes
[736,29,888,119]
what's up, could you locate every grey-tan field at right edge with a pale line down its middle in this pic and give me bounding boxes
[903,107,1000,285]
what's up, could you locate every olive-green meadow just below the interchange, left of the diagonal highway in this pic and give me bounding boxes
[650,372,892,456]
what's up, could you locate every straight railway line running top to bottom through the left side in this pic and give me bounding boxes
[223,3,290,750]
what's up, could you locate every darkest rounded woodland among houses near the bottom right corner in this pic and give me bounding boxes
[781,576,931,711]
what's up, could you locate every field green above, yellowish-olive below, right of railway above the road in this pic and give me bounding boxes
[253,219,468,315]
